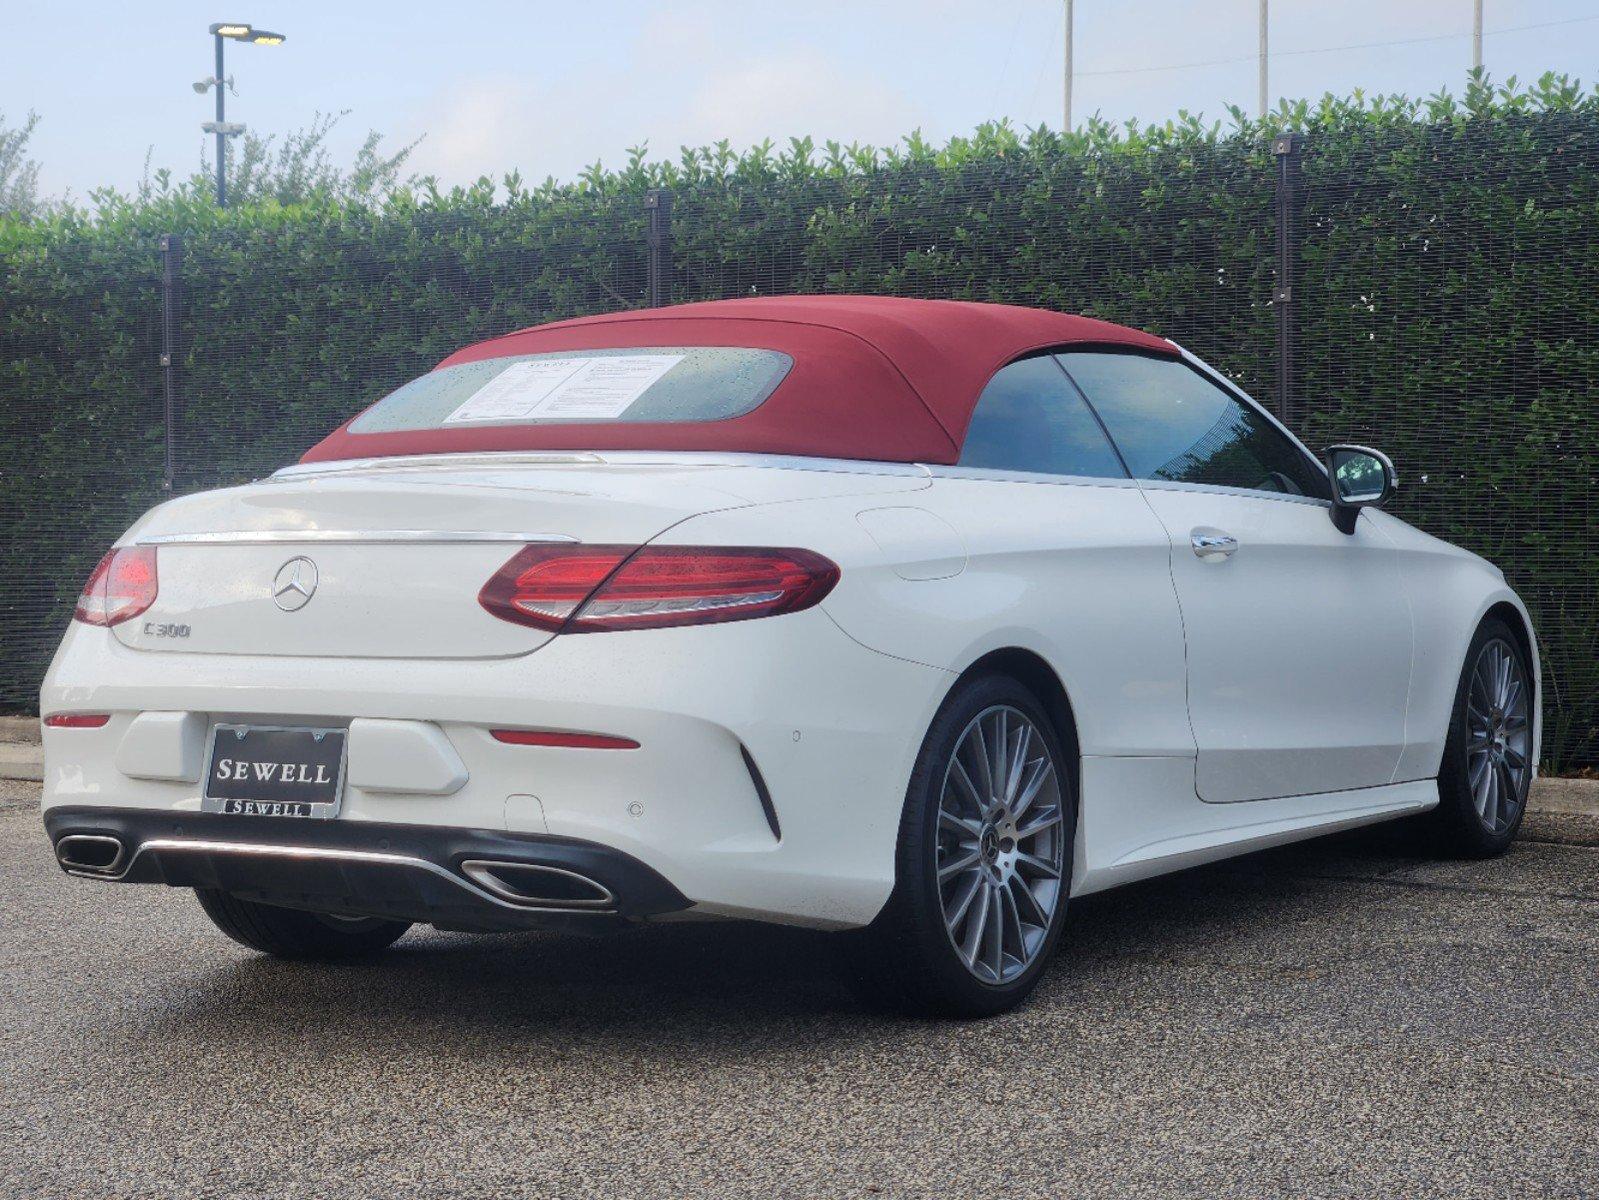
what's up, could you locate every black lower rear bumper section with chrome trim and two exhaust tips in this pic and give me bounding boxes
[45,808,689,931]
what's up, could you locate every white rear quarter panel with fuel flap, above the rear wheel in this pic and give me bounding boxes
[660,475,1194,757]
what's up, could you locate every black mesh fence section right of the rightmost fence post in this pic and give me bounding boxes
[1295,114,1599,766]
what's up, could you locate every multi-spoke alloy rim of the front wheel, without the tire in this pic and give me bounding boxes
[1466,638,1532,834]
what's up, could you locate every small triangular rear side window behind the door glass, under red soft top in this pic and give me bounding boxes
[961,355,1127,478]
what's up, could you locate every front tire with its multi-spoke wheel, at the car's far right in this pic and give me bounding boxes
[1428,618,1535,858]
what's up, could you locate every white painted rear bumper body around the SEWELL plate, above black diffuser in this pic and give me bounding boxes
[40,610,953,928]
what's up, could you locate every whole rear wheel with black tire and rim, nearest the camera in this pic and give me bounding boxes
[839,675,1078,1018]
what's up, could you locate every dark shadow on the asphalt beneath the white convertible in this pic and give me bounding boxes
[134,832,1439,1050]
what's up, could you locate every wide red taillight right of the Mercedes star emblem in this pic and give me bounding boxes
[478,546,838,634]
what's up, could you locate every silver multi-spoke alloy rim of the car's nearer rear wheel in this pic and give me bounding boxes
[937,704,1067,984]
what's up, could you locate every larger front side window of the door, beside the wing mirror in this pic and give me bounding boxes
[1060,350,1327,499]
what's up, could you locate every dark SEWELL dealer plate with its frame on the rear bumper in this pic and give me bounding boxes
[200,722,350,821]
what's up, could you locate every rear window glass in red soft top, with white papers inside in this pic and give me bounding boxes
[350,346,793,434]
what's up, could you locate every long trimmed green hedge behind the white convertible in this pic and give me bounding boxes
[0,78,1599,766]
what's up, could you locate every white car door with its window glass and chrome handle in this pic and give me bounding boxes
[1060,352,1414,802]
